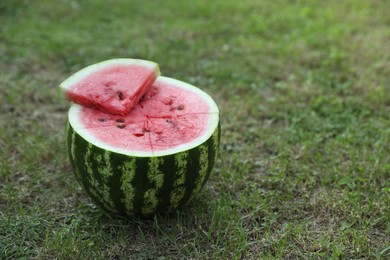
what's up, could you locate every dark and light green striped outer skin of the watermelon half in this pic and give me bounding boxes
[68,120,220,216]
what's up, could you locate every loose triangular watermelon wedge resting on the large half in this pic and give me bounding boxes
[60,59,160,115]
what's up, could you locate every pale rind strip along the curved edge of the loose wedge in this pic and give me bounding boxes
[60,58,160,91]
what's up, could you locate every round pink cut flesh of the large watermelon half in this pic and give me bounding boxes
[79,79,215,151]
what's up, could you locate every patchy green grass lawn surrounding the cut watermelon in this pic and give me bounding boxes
[0,0,390,259]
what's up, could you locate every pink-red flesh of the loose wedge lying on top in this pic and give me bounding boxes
[67,65,157,115]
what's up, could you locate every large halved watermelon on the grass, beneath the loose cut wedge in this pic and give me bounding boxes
[67,61,220,216]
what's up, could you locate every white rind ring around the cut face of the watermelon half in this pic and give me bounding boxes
[68,75,219,157]
